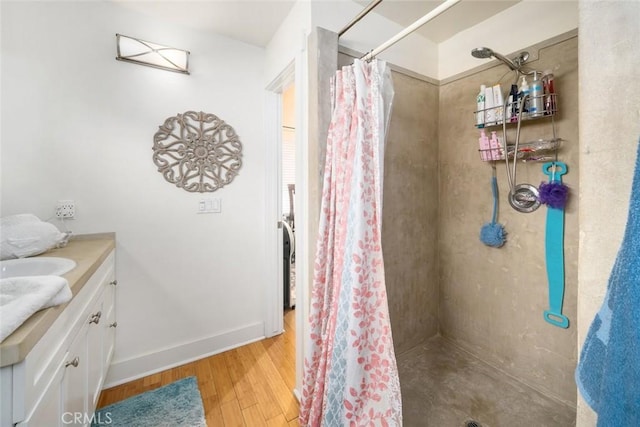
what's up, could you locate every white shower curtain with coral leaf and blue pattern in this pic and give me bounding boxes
[300,60,402,427]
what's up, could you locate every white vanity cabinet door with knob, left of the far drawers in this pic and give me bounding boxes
[61,322,90,426]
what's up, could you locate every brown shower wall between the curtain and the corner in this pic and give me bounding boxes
[382,72,438,353]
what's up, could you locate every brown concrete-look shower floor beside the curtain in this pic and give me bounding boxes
[397,336,576,427]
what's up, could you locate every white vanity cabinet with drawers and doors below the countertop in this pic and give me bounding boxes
[2,251,117,427]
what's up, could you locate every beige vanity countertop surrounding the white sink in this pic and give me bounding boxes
[0,233,116,367]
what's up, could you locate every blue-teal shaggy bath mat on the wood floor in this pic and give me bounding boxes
[91,377,207,427]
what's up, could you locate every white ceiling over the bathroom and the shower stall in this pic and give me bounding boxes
[112,0,520,47]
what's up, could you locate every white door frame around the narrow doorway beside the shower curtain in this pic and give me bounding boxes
[265,49,310,400]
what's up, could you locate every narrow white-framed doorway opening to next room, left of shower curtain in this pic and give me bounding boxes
[265,56,309,399]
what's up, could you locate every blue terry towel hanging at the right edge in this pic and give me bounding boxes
[576,140,640,427]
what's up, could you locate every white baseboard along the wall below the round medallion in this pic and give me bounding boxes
[103,322,264,389]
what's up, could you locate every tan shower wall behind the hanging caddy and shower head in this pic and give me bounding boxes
[440,36,579,406]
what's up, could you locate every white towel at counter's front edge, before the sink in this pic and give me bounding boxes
[0,276,72,342]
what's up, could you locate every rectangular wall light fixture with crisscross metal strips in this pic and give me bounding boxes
[116,34,189,74]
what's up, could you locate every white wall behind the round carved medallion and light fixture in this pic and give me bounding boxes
[1,2,267,383]
